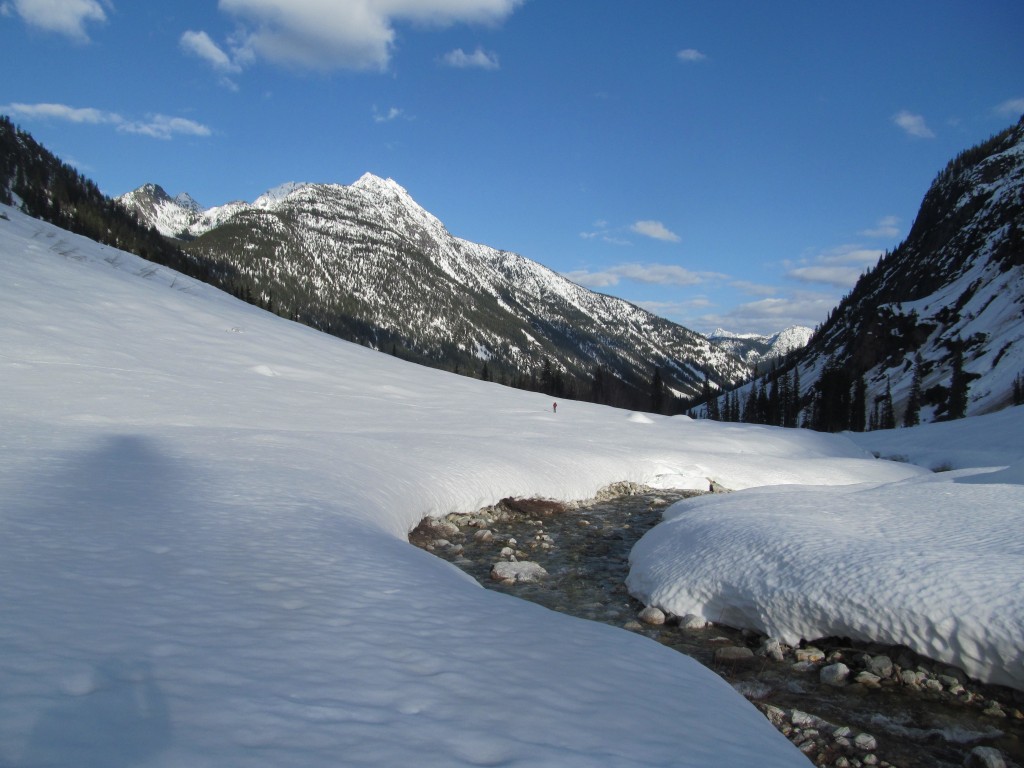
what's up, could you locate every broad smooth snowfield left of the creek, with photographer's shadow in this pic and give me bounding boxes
[0,208,1007,766]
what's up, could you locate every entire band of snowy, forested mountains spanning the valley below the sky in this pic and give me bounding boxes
[6,111,1024,430]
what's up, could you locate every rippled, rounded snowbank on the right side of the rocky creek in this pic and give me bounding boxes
[628,421,1024,689]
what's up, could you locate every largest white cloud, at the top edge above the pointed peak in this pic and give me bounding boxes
[211,0,524,71]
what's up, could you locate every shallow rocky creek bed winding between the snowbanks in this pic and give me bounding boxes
[410,483,1024,768]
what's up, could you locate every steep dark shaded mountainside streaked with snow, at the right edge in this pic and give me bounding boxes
[801,119,1024,421]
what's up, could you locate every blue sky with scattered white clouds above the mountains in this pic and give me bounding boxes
[0,0,1024,333]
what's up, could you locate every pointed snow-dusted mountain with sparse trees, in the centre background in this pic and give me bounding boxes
[118,173,751,404]
